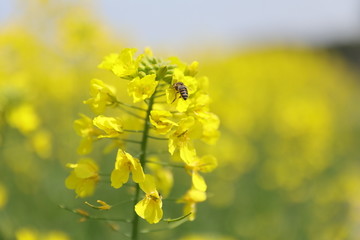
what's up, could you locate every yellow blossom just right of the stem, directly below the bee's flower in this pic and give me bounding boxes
[169,116,196,163]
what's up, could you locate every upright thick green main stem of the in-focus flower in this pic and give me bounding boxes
[131,85,156,240]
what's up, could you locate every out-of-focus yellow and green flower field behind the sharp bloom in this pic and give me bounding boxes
[0,1,360,240]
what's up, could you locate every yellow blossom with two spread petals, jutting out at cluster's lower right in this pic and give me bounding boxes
[186,155,217,192]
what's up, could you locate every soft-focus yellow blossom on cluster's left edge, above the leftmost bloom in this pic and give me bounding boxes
[74,114,101,155]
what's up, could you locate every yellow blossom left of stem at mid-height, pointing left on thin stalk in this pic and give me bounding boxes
[93,115,124,138]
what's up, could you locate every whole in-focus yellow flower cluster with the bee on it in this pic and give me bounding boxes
[66,49,219,228]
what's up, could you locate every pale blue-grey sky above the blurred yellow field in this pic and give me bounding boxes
[0,0,360,52]
